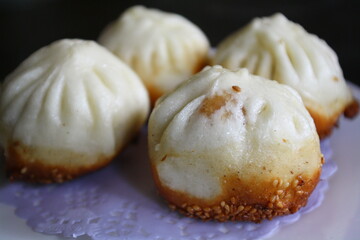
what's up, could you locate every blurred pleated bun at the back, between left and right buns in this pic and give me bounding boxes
[99,6,209,104]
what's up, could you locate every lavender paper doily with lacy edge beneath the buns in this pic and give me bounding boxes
[0,132,337,240]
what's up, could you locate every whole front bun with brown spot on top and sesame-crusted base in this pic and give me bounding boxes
[148,66,323,222]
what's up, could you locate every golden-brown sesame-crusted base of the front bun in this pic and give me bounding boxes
[152,163,321,223]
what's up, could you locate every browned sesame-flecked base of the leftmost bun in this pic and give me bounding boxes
[5,142,113,183]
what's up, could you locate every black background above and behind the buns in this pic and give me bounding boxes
[0,0,360,85]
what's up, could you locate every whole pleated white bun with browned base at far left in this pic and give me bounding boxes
[0,40,149,183]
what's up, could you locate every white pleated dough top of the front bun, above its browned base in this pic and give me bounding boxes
[149,66,321,199]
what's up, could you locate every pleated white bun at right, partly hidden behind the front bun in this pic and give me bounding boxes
[212,14,358,137]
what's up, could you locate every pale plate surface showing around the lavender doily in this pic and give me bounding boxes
[0,86,360,240]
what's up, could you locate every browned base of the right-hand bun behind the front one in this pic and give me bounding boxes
[308,99,359,139]
